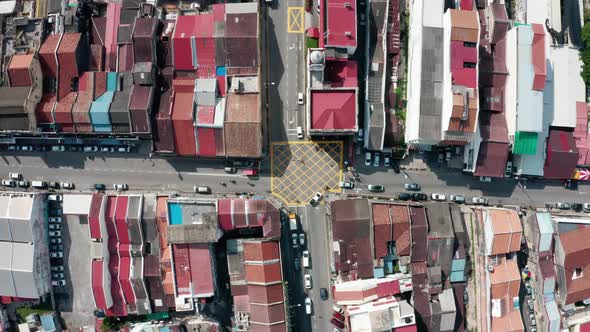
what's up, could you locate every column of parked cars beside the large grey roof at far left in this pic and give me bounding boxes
[47,194,66,287]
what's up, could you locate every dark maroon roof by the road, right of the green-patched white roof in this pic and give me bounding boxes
[543,128,579,179]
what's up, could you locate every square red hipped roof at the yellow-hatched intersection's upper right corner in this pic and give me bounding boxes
[311,90,357,130]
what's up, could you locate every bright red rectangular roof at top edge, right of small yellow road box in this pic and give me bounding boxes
[322,0,357,47]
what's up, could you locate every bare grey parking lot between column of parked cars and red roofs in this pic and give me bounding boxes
[54,210,95,327]
